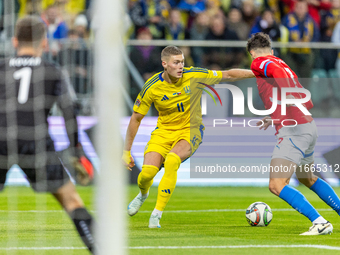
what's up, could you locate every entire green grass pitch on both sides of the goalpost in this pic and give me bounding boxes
[0,185,340,255]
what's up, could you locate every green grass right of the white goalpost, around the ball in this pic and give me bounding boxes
[129,187,340,255]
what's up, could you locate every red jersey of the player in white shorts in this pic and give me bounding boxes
[251,55,313,132]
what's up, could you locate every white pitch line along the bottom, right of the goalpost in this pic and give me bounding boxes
[129,244,340,251]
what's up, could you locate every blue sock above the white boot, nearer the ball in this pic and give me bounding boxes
[279,185,320,222]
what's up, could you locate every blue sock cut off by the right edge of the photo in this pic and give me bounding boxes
[310,178,340,215]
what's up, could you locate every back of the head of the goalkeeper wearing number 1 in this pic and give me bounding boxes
[15,15,46,48]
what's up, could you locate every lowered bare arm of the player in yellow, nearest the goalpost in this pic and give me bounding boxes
[122,112,145,171]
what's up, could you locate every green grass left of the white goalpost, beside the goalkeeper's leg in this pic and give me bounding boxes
[0,186,94,255]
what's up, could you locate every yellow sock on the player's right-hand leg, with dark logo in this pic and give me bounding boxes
[156,152,181,211]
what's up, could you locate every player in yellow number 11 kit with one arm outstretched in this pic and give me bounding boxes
[123,46,254,228]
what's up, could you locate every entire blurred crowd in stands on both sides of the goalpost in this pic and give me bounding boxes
[0,0,340,114]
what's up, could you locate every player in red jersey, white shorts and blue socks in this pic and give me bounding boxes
[247,33,340,235]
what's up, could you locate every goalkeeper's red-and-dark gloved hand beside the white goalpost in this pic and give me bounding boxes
[71,143,94,186]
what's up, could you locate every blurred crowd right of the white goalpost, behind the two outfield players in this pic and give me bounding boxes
[128,0,340,79]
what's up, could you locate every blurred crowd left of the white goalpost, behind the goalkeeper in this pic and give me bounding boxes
[0,0,93,94]
